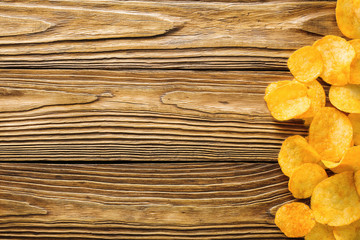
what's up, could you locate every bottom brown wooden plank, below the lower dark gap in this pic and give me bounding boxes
[0,163,298,239]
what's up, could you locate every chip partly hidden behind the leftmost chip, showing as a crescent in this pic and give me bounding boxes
[297,80,326,119]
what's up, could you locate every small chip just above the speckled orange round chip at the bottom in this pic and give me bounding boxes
[289,163,327,198]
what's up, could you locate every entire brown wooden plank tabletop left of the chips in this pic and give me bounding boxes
[0,0,341,240]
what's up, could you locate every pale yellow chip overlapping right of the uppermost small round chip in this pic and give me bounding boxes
[314,35,355,86]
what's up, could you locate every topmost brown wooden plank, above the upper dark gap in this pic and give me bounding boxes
[0,0,341,70]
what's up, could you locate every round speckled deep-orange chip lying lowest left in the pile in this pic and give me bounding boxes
[275,202,315,237]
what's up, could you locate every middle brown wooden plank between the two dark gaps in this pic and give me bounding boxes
[0,70,307,161]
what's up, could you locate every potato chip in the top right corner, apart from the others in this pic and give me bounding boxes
[336,0,360,38]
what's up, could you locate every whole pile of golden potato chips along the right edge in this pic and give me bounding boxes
[264,0,360,240]
